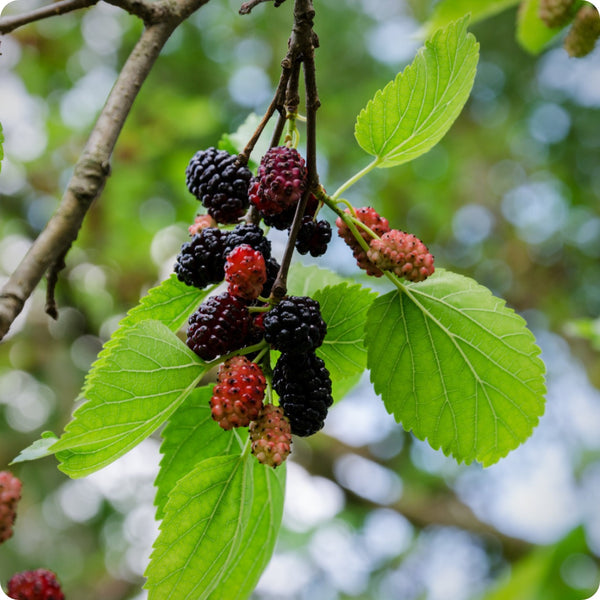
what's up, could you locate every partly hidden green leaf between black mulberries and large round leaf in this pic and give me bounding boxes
[312,283,377,380]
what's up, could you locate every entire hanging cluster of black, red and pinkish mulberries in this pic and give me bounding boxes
[175,143,438,467]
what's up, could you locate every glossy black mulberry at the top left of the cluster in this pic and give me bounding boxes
[185,148,252,223]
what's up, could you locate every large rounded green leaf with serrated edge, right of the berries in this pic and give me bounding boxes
[366,270,545,466]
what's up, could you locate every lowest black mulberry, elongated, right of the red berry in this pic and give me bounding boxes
[273,352,333,437]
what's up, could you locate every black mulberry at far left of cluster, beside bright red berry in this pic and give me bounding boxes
[175,227,229,289]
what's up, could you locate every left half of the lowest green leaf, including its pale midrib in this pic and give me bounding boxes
[146,454,257,600]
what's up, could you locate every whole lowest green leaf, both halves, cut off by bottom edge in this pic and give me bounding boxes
[146,452,283,600]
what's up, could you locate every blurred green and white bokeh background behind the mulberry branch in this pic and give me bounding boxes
[0,0,600,600]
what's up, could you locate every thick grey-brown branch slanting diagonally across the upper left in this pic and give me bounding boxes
[0,0,209,339]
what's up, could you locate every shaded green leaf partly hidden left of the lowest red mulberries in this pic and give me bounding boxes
[154,385,240,519]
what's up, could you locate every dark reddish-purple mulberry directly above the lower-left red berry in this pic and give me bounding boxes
[186,292,250,361]
